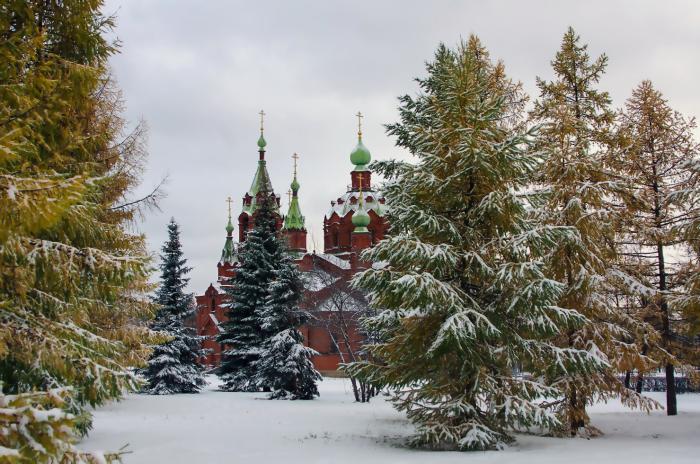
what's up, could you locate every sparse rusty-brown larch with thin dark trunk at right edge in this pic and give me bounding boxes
[616,81,700,415]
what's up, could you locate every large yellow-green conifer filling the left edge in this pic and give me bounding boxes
[0,0,155,463]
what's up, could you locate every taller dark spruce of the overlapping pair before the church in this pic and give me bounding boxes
[217,191,280,391]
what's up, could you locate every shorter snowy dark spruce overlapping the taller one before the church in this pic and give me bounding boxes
[257,252,321,400]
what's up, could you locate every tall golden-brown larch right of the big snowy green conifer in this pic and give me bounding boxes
[531,28,654,435]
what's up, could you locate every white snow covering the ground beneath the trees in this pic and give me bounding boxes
[80,377,700,464]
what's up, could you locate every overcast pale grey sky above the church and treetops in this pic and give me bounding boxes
[105,0,700,293]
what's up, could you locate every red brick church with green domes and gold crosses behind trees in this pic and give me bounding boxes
[195,111,388,374]
